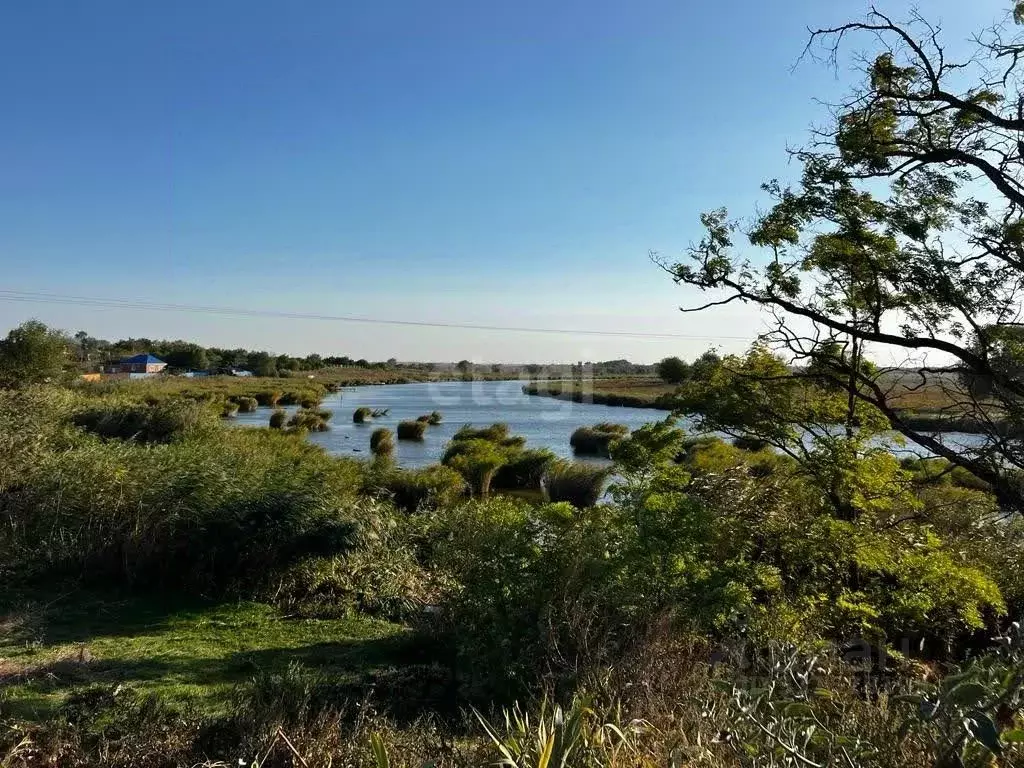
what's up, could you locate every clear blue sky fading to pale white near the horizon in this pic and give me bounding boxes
[0,0,1009,361]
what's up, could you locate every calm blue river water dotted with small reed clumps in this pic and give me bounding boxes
[234,381,668,467]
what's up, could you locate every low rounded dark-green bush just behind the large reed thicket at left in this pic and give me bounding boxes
[72,400,216,442]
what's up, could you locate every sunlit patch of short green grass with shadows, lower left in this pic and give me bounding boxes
[0,594,415,719]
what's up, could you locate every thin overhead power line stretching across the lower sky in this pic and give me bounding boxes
[0,290,751,341]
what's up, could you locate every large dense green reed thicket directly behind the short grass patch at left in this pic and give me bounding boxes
[4,415,365,599]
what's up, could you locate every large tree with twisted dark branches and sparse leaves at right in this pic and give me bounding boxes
[654,6,1024,511]
